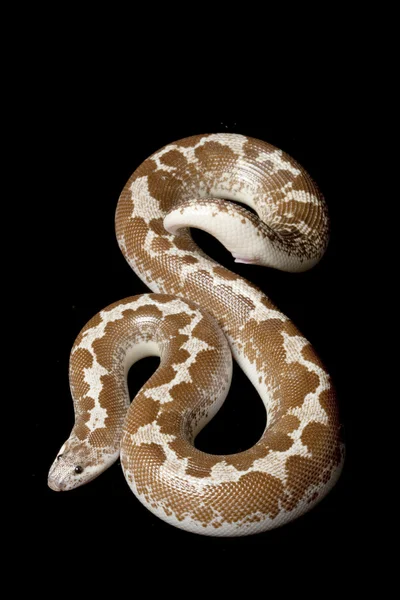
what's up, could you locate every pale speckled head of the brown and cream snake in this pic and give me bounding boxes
[47,437,118,492]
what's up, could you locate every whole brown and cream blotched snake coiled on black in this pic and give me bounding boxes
[48,134,344,536]
